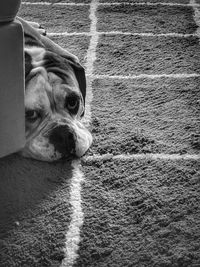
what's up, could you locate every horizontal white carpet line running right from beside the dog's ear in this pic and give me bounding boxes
[92,73,200,80]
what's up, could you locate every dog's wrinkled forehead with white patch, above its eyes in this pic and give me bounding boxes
[25,47,79,107]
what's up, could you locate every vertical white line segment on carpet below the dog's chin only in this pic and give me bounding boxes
[60,160,84,267]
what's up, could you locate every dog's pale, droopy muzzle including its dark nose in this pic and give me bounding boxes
[21,121,92,161]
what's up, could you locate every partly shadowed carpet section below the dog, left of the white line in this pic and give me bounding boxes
[0,154,72,267]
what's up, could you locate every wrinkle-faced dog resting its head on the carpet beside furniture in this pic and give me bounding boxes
[17,17,92,161]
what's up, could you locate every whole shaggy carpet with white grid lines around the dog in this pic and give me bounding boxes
[0,0,200,267]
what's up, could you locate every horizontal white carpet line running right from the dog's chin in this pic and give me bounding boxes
[83,153,200,162]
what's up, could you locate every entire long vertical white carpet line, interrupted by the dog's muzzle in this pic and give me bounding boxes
[60,0,98,267]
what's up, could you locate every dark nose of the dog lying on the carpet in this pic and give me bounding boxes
[49,125,75,156]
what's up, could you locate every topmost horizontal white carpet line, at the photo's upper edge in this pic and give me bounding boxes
[22,2,200,7]
